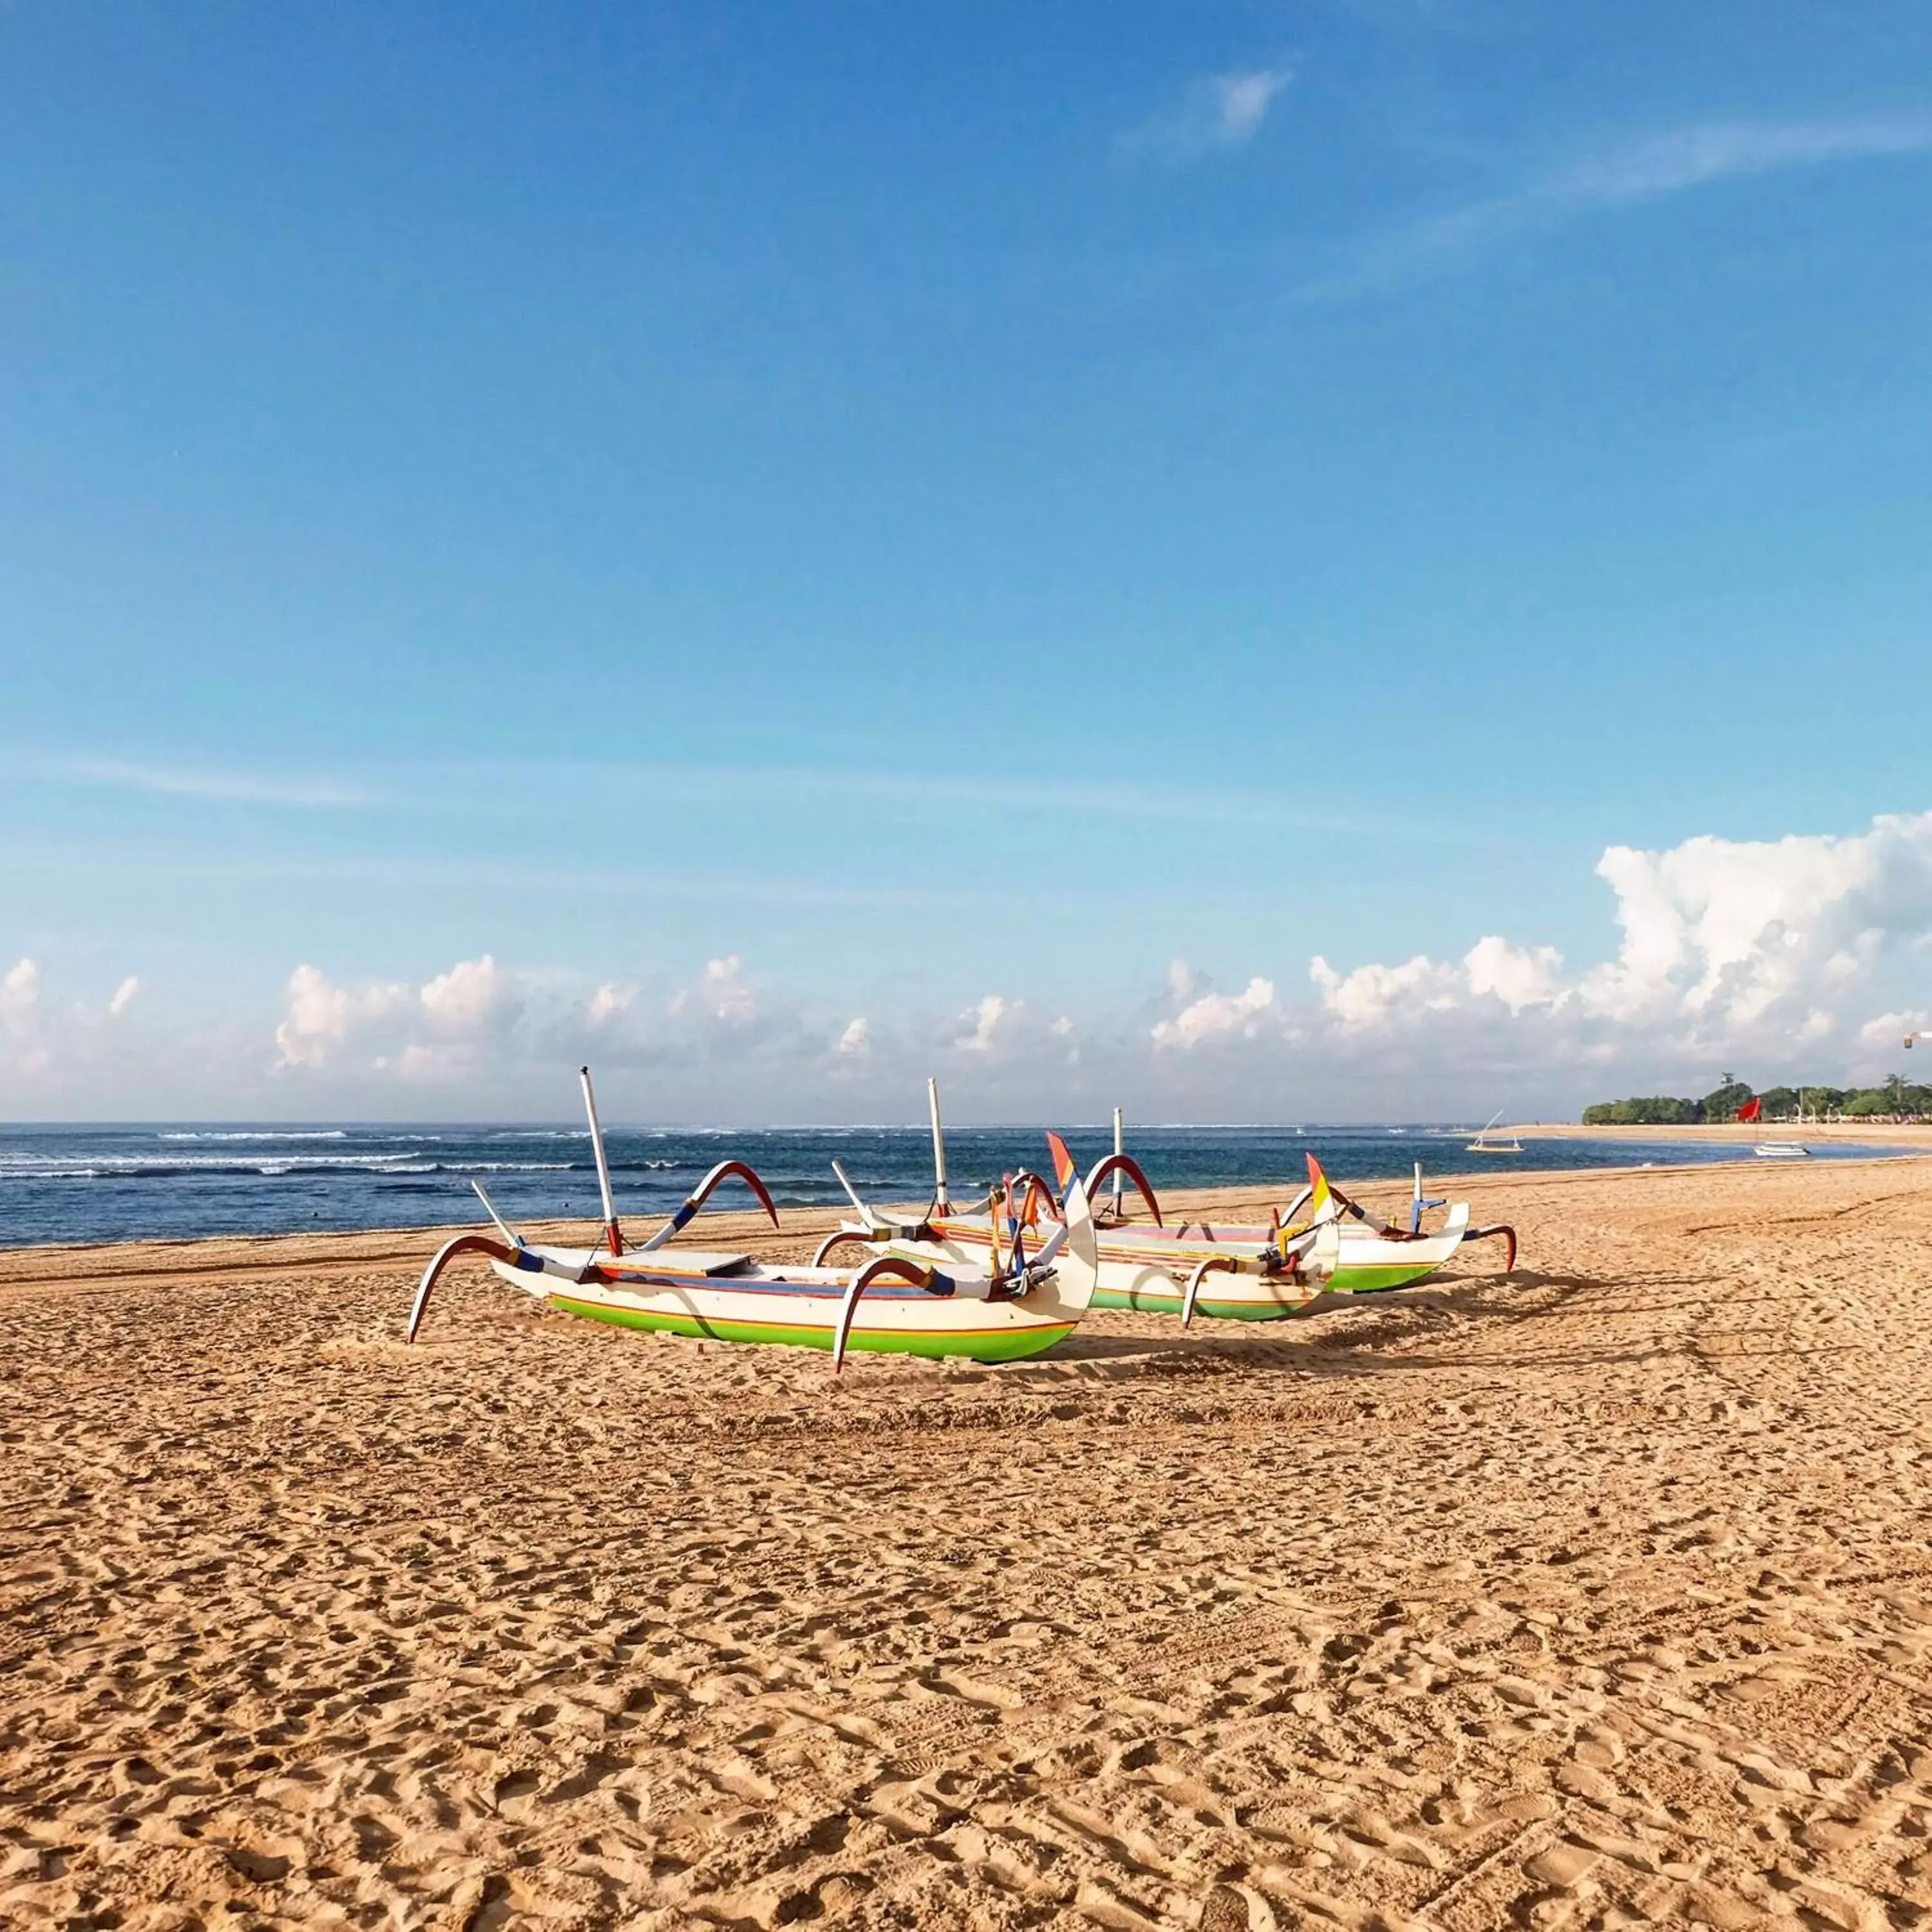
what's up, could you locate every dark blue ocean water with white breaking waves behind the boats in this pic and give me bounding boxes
[0,1122,1897,1248]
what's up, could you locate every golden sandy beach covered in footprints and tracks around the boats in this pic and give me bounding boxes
[0,1151,1932,1932]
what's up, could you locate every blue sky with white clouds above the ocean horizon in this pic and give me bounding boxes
[0,0,1932,1119]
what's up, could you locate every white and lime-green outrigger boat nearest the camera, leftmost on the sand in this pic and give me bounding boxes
[408,1066,1097,1374]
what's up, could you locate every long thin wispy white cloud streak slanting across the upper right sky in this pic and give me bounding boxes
[1300,116,1932,301]
